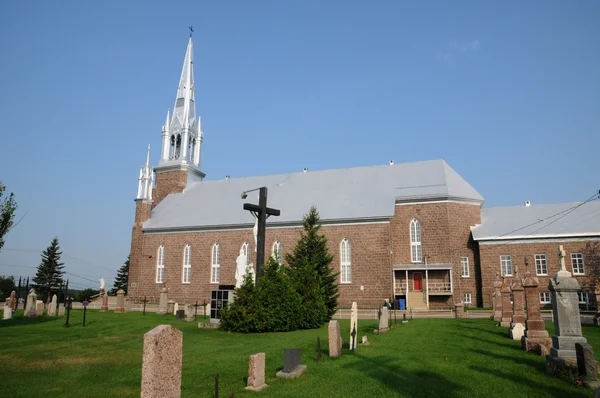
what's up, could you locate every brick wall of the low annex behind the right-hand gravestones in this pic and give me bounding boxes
[479,240,589,306]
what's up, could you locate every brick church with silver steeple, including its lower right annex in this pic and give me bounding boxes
[128,37,600,311]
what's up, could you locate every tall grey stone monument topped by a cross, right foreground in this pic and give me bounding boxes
[546,245,587,375]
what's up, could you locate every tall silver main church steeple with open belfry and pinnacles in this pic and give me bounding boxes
[159,37,201,171]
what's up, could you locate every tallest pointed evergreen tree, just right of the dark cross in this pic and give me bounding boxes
[285,206,339,321]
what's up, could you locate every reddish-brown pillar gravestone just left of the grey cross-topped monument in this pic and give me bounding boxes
[521,272,552,355]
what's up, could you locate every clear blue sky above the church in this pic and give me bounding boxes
[0,0,600,287]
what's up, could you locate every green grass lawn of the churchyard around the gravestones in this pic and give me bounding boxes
[0,310,600,397]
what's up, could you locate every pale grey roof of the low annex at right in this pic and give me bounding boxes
[471,201,600,243]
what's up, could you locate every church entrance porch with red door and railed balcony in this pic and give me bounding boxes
[393,264,454,311]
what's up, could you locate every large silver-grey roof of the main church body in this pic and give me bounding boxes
[144,160,483,231]
